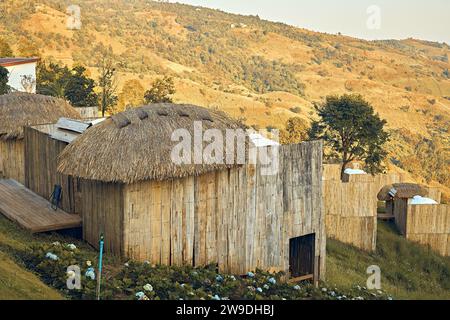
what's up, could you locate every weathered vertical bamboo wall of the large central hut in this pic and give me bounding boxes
[81,142,326,279]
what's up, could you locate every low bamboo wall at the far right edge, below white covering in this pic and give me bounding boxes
[395,199,450,256]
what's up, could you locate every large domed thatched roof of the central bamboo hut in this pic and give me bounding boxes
[58,104,248,183]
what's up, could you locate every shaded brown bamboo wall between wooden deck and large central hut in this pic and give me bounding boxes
[24,125,78,213]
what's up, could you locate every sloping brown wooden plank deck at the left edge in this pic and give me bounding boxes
[0,179,81,233]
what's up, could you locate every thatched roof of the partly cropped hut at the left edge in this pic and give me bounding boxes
[0,92,80,140]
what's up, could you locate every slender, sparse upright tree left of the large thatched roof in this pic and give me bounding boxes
[98,52,117,117]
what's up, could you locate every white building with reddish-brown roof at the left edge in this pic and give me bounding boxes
[0,58,39,93]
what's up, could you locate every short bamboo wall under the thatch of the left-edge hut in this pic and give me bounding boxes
[0,139,25,184]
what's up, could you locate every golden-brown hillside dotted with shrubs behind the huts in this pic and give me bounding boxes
[0,0,450,187]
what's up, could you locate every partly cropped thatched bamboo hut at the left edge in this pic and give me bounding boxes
[0,92,80,184]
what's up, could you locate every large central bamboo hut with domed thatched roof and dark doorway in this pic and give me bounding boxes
[58,104,325,280]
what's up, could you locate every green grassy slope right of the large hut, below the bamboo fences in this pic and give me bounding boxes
[327,222,450,299]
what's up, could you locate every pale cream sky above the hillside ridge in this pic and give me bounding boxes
[171,0,450,44]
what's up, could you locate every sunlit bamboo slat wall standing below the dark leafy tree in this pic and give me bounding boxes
[323,164,406,251]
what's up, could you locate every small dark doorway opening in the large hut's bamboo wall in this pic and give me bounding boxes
[289,233,316,280]
